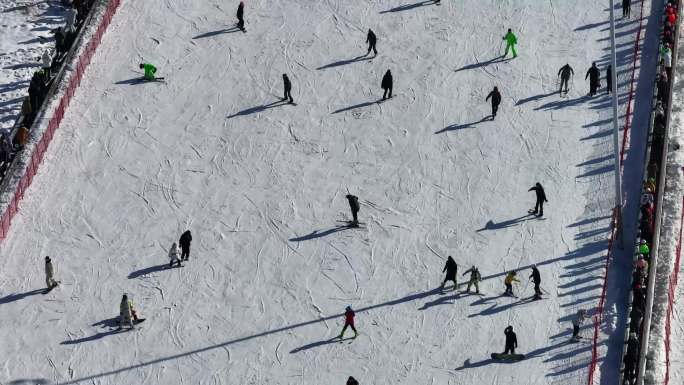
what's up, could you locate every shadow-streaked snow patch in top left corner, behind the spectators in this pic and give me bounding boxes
[0,0,64,128]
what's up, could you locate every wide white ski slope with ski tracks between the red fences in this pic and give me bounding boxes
[0,0,650,384]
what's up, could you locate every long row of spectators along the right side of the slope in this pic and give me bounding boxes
[622,0,679,384]
